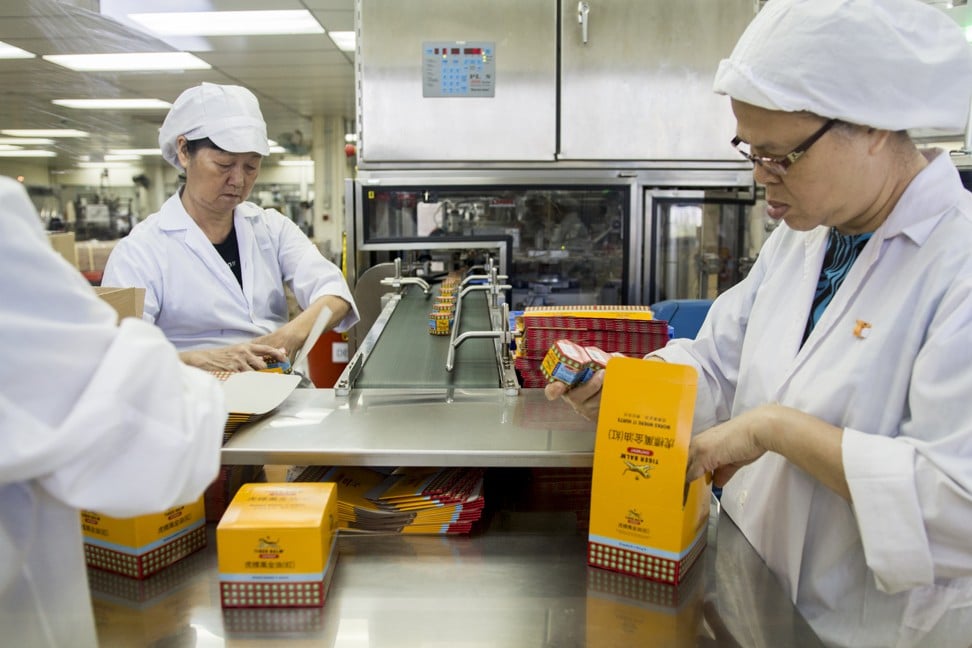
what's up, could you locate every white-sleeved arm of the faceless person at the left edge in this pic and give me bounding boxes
[0,173,226,516]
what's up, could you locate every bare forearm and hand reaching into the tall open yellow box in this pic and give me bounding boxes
[686,404,850,500]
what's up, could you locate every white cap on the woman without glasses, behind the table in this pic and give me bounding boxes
[159,83,270,171]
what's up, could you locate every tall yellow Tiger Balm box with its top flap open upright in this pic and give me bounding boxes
[587,357,711,583]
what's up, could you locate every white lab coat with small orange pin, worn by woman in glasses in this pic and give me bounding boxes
[657,149,972,646]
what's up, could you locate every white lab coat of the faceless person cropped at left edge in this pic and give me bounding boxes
[0,178,226,648]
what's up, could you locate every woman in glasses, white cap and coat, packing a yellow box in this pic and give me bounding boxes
[547,0,972,647]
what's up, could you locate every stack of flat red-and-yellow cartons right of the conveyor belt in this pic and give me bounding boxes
[514,306,670,388]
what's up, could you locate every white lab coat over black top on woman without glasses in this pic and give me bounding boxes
[102,192,358,351]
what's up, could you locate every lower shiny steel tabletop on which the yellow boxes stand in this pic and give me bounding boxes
[89,512,822,648]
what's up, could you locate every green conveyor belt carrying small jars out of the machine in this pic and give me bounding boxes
[355,286,500,388]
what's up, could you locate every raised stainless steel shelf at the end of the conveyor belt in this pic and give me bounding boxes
[222,389,595,468]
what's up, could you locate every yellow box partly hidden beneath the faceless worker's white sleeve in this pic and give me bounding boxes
[81,497,206,579]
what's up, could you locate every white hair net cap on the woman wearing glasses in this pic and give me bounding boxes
[713,0,972,133]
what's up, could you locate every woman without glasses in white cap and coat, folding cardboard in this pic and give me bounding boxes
[102,83,358,371]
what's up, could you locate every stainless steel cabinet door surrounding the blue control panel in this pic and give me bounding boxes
[357,0,557,162]
